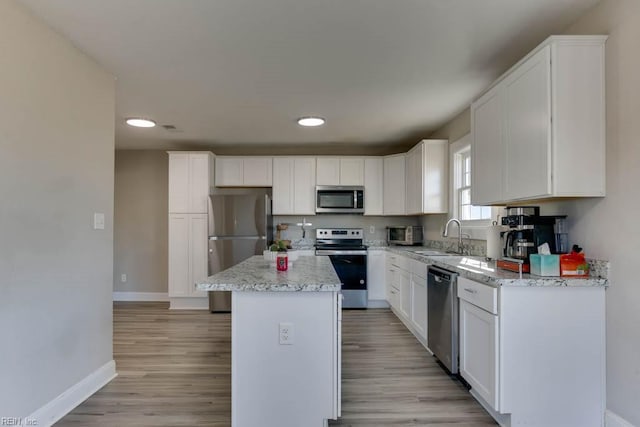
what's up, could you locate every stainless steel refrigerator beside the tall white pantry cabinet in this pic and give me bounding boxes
[209,189,273,313]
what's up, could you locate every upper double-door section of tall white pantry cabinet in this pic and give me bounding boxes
[169,151,214,213]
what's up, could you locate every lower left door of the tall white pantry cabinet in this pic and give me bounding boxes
[168,214,189,297]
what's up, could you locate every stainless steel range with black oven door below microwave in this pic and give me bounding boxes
[316,228,368,308]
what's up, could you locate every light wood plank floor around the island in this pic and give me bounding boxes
[56,303,496,427]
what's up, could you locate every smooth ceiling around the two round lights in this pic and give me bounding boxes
[22,0,597,154]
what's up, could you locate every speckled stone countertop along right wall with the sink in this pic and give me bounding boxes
[379,246,609,287]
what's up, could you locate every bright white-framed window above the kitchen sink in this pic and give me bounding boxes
[449,134,500,239]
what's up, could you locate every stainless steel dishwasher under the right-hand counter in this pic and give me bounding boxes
[427,266,459,374]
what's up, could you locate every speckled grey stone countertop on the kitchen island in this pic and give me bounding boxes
[196,255,340,292]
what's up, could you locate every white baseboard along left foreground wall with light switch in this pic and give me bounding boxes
[26,360,118,427]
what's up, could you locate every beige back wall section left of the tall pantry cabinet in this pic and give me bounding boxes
[113,150,169,293]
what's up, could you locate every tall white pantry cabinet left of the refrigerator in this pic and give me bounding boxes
[168,151,214,309]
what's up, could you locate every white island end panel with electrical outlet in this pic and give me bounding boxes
[231,292,342,427]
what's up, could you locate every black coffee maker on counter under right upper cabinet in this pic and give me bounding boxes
[498,206,566,273]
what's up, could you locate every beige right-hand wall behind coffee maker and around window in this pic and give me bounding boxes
[423,0,640,426]
